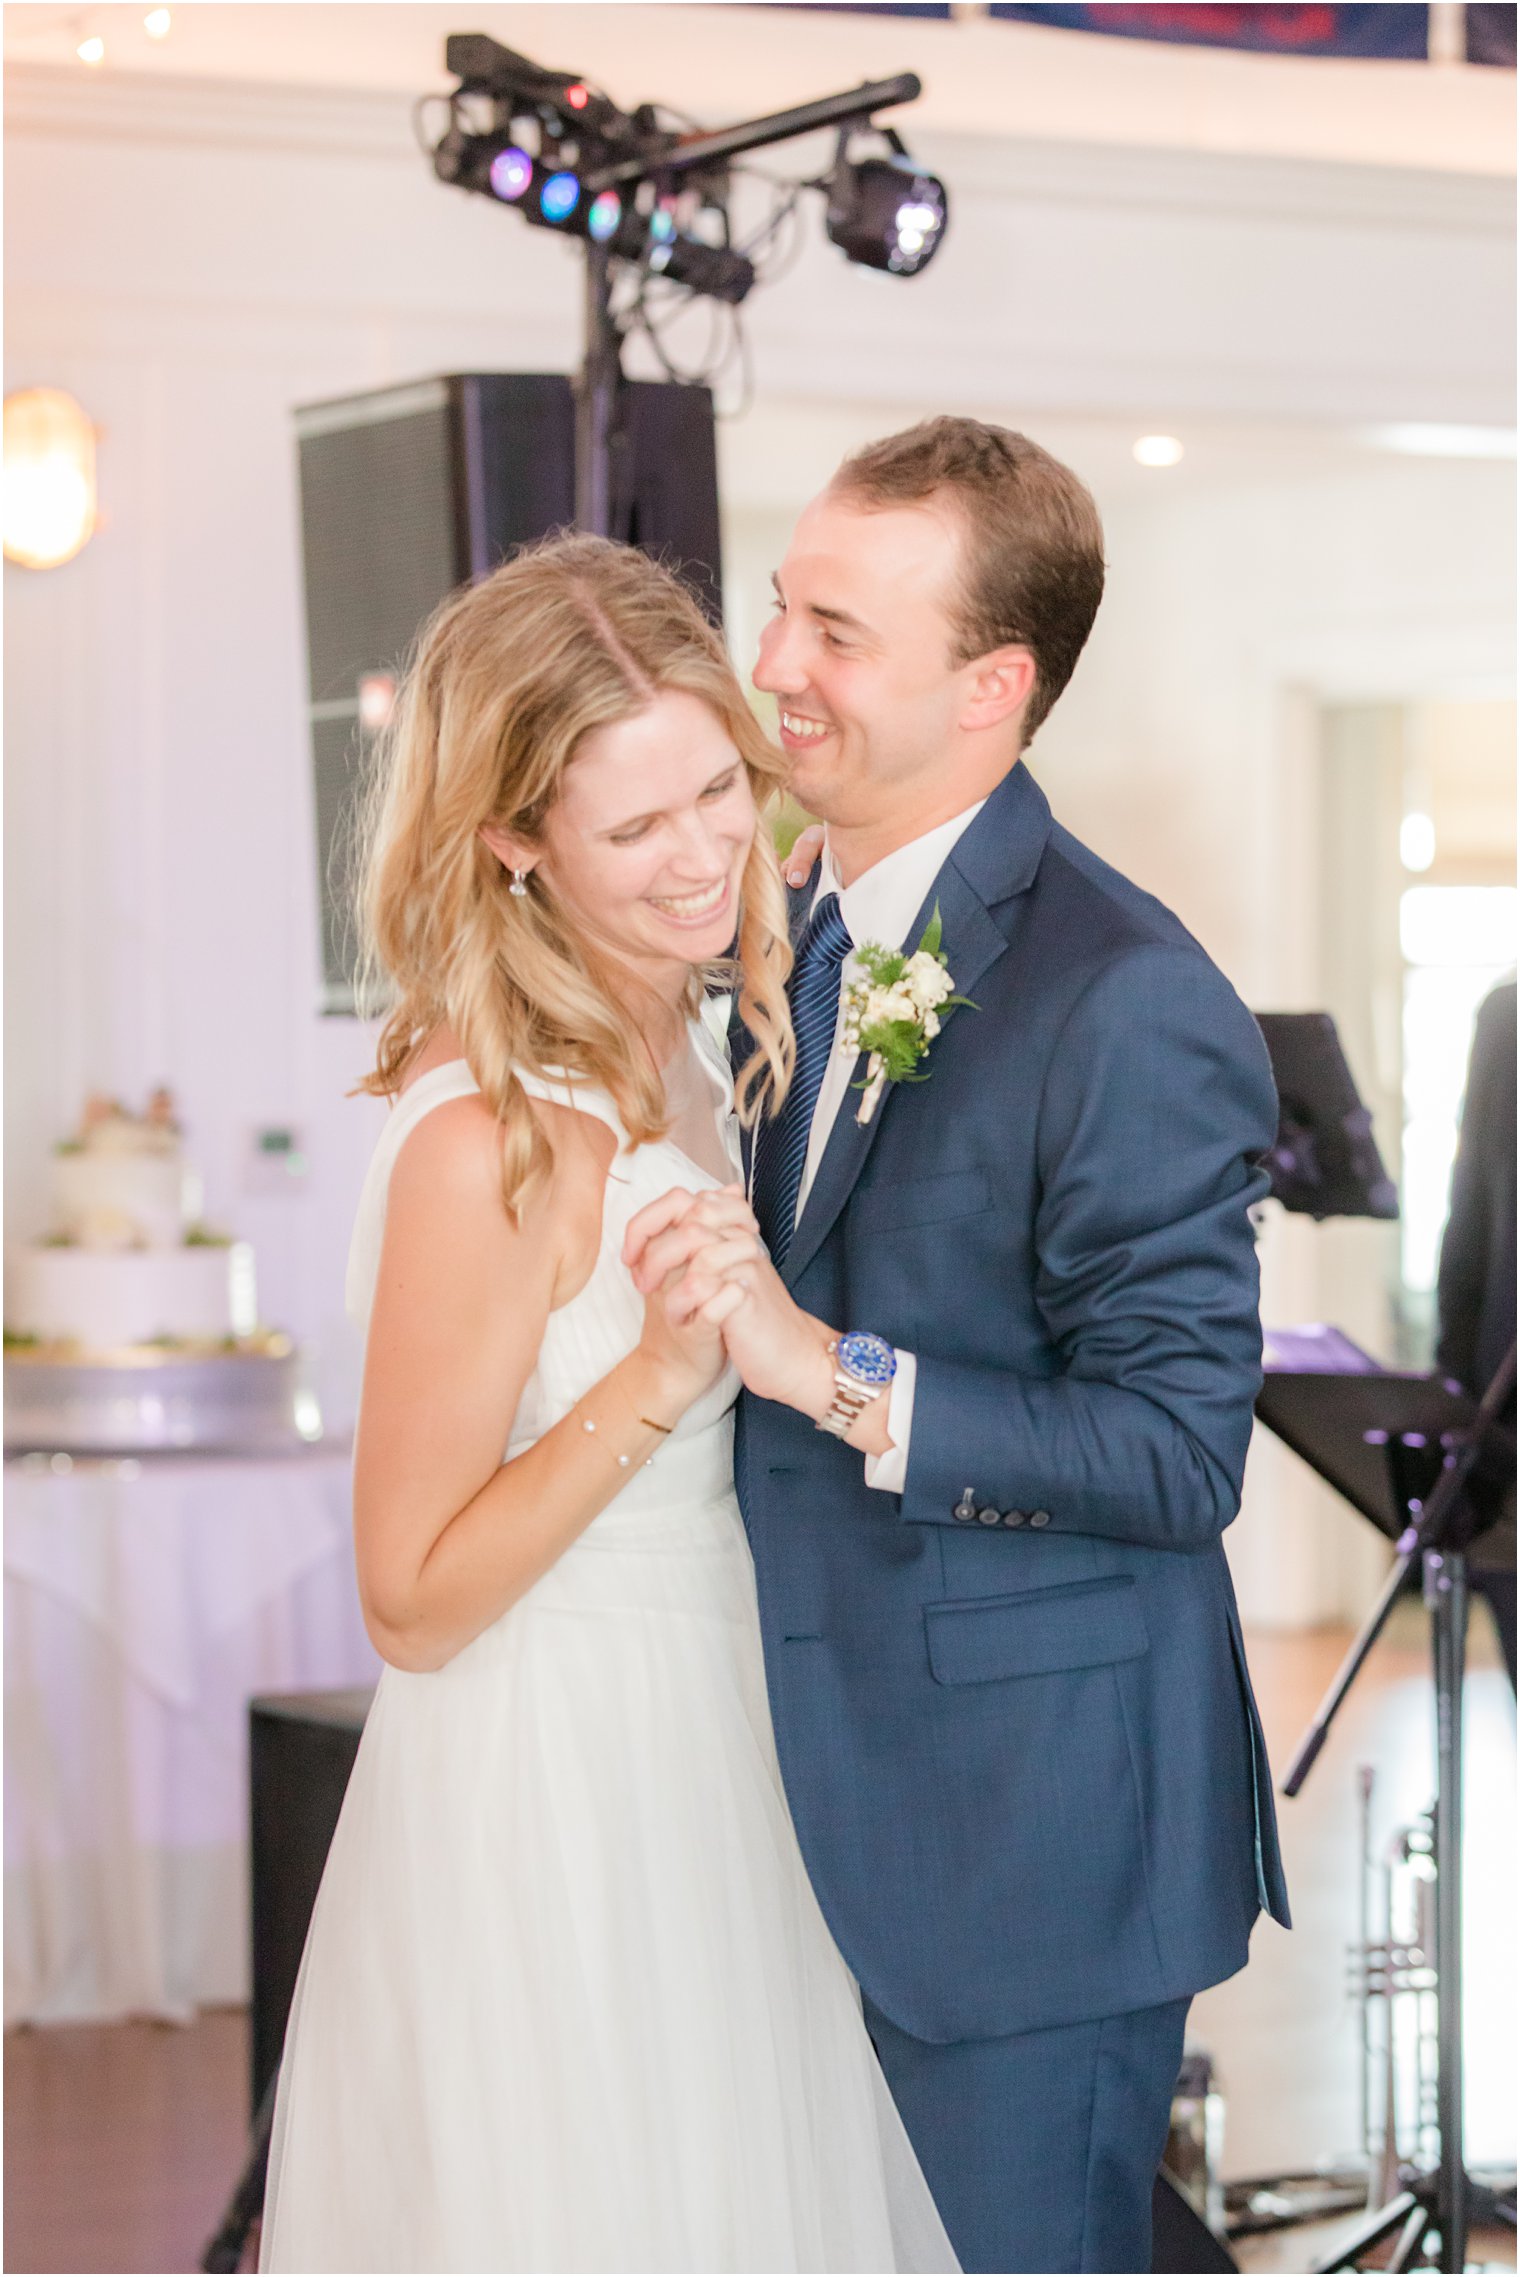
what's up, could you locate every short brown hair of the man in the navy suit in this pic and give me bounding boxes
[828,419,1104,742]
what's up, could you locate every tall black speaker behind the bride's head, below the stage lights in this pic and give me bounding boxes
[296,371,724,1013]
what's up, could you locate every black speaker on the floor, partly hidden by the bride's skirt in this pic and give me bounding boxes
[248,1687,373,2111]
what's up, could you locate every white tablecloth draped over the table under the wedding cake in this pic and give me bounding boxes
[5,1448,378,2024]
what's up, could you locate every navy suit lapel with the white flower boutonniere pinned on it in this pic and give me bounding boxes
[780,761,1051,1287]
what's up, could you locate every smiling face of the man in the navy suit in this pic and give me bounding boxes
[755,490,1026,838]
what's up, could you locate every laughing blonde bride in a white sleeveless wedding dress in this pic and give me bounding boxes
[262,537,956,2270]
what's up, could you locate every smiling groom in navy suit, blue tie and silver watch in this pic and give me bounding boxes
[637,419,1288,2270]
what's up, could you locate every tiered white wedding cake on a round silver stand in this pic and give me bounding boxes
[5,1091,321,1450]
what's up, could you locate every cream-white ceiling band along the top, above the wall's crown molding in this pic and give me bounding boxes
[5,0,1515,175]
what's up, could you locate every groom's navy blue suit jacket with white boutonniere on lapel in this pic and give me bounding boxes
[737,765,1288,2042]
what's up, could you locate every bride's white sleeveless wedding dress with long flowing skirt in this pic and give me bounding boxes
[262,1022,956,2270]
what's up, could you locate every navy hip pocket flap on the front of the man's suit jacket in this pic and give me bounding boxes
[924,1573,1149,1685]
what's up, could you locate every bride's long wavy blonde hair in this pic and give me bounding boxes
[360,535,794,1216]
